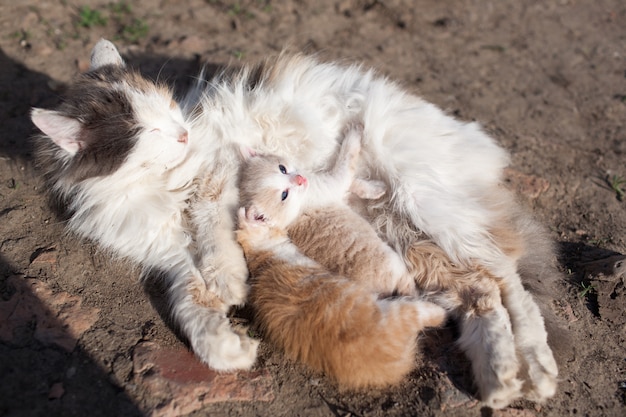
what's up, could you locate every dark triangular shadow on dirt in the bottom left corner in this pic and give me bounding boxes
[0,252,142,417]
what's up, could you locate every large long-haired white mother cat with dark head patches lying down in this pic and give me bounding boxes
[32,40,557,407]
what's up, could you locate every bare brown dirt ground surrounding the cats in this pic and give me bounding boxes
[0,0,626,417]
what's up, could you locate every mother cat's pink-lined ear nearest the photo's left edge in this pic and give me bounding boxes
[30,108,84,155]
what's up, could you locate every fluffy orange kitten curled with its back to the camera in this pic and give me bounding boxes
[238,230,445,388]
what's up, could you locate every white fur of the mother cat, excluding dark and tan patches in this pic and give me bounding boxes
[33,41,556,400]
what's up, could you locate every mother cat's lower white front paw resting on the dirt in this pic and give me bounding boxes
[190,317,259,371]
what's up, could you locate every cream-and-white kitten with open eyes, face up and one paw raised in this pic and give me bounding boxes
[239,124,417,295]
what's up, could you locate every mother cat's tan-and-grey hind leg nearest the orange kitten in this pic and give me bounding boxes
[405,241,522,408]
